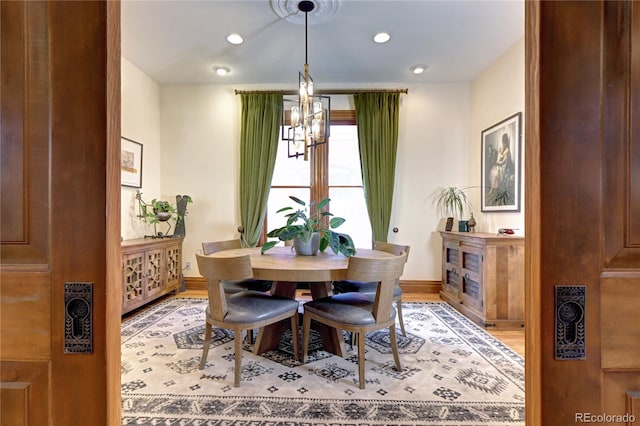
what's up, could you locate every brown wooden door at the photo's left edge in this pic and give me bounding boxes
[0,0,121,426]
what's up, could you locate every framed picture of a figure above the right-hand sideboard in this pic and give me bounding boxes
[480,112,522,212]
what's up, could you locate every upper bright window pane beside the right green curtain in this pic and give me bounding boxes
[329,126,362,186]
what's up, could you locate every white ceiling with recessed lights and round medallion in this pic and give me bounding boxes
[121,0,524,89]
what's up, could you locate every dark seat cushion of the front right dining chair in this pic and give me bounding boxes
[303,292,396,326]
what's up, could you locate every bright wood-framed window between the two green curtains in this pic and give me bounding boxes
[263,111,372,247]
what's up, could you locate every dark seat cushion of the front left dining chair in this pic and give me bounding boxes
[207,291,298,323]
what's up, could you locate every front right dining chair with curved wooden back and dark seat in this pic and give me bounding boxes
[302,252,407,389]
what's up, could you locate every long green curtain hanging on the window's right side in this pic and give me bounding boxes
[353,92,400,242]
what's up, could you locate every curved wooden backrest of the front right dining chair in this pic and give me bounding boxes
[347,251,407,322]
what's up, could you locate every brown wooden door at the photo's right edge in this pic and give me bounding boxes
[526,1,640,425]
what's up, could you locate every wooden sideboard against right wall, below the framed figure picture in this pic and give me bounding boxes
[440,232,524,329]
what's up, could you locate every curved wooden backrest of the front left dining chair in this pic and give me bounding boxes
[196,253,253,321]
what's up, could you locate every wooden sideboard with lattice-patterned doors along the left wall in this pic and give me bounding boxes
[122,238,182,314]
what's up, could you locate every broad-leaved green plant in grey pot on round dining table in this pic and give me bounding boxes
[261,195,356,256]
